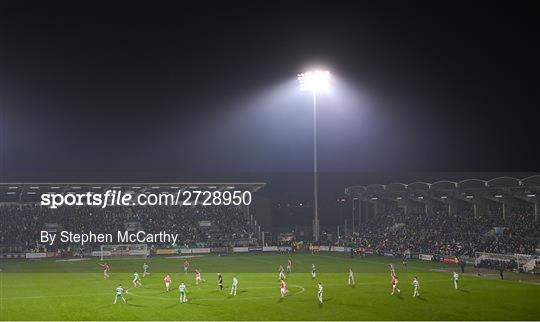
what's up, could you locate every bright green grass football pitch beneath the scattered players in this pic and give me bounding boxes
[0,253,540,320]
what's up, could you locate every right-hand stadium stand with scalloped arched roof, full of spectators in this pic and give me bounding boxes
[344,175,540,268]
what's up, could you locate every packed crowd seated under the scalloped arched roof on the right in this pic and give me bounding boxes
[341,208,540,256]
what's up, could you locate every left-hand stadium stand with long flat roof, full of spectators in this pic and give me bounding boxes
[0,183,264,253]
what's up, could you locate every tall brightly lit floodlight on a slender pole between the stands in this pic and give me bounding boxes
[298,70,330,242]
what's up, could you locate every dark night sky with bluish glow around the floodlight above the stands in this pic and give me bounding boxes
[0,1,540,181]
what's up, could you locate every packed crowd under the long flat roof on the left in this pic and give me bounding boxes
[0,204,255,251]
